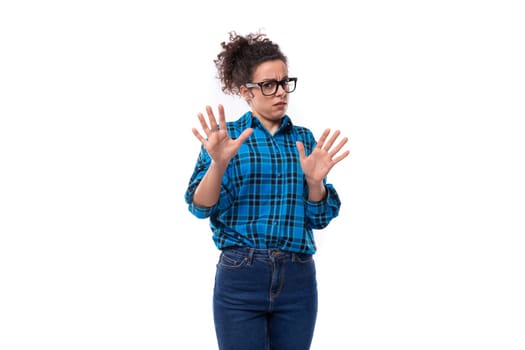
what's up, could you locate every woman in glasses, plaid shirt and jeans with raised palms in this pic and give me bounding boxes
[185,32,349,350]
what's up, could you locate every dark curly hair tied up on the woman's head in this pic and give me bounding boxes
[214,31,287,95]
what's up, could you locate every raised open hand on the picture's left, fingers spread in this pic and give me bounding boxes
[192,104,253,166]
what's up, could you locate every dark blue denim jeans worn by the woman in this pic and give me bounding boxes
[213,248,317,350]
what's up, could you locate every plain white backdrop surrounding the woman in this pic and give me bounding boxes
[0,0,525,350]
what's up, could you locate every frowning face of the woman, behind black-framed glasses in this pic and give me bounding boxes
[241,60,288,132]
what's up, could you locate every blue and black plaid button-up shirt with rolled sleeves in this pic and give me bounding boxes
[185,112,341,254]
